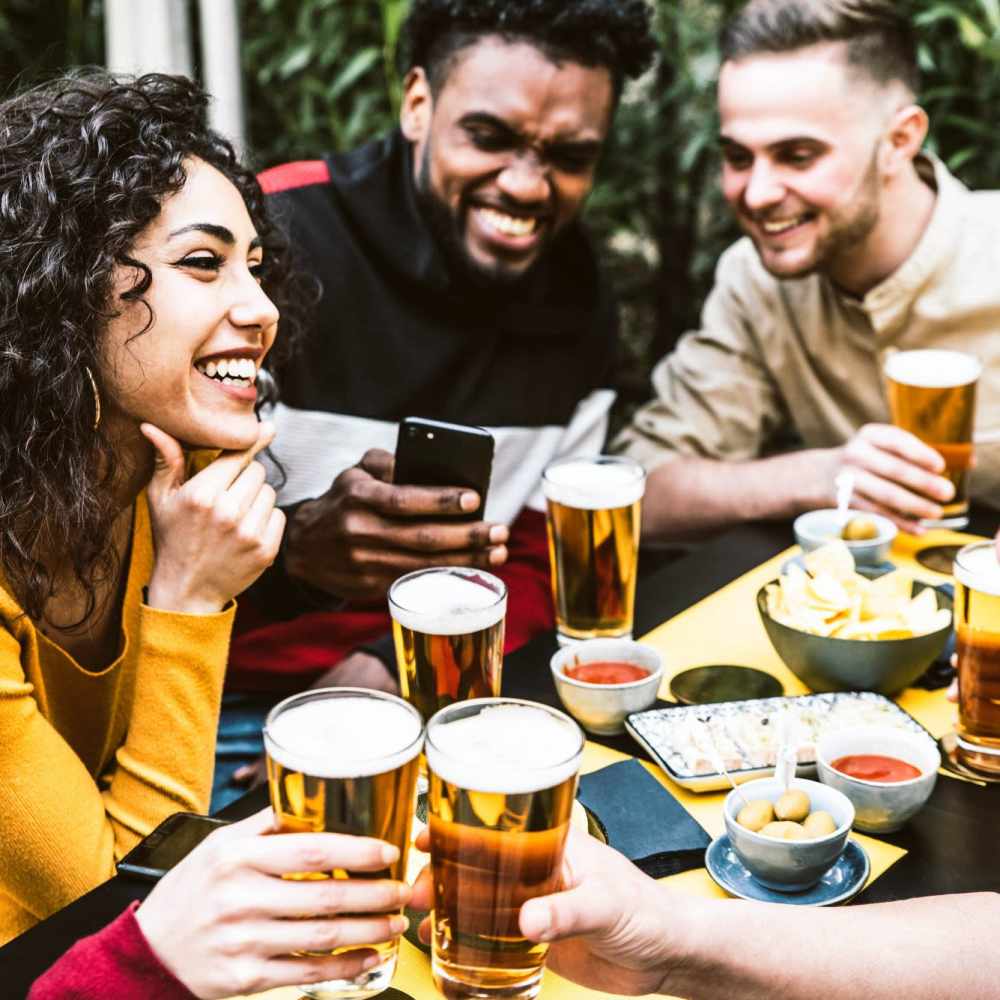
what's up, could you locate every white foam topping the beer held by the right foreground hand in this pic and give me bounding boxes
[425,705,583,795]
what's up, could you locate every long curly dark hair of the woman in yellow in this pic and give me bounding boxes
[0,70,300,624]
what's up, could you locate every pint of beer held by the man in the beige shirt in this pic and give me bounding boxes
[885,351,982,528]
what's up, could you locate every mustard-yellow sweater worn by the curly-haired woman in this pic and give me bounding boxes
[0,494,234,944]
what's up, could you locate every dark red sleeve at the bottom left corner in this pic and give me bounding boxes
[28,903,196,1000]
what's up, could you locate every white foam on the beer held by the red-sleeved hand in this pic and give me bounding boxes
[264,697,423,778]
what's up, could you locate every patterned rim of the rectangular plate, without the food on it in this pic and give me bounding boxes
[625,691,936,792]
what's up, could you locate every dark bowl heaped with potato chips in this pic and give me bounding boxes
[757,541,952,695]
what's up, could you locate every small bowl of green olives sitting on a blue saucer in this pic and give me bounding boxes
[723,778,854,892]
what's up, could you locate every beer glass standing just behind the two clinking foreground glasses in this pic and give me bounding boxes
[389,567,507,719]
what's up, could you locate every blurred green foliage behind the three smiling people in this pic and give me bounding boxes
[0,0,1000,414]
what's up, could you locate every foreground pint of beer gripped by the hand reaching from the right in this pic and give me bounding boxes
[427,698,583,998]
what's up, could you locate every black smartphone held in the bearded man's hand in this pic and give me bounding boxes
[393,417,493,521]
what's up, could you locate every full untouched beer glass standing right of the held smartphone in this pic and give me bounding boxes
[542,455,646,643]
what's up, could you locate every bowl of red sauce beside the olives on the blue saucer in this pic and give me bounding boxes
[816,726,941,833]
